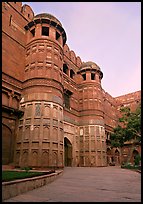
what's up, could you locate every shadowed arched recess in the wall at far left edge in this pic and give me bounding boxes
[2,124,13,165]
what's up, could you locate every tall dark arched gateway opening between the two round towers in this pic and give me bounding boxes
[64,137,72,166]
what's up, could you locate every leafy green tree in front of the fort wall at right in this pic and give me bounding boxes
[110,105,141,147]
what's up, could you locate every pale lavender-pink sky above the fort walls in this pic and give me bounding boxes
[22,2,141,97]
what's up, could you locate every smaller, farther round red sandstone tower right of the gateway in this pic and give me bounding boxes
[77,61,107,166]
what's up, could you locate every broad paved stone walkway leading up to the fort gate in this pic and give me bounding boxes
[5,166,141,202]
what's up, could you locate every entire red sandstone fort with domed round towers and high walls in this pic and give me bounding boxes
[2,2,141,167]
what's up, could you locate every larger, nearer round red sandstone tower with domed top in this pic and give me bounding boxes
[16,13,66,167]
